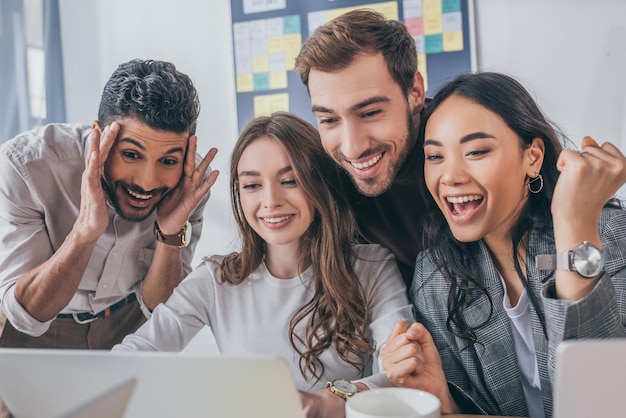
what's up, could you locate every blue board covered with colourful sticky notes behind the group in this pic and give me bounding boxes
[231,0,476,132]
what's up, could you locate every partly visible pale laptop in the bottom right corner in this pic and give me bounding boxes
[553,338,626,418]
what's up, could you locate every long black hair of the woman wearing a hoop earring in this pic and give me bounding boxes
[421,72,567,344]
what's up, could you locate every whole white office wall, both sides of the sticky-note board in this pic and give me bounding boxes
[61,0,626,268]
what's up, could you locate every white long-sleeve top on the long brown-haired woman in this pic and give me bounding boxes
[113,244,414,390]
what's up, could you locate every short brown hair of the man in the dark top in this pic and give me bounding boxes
[295,9,417,94]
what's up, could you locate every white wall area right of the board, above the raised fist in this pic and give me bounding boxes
[475,0,626,150]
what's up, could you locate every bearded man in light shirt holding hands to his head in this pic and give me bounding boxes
[0,60,218,349]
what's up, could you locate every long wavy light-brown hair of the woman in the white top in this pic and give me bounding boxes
[221,112,374,382]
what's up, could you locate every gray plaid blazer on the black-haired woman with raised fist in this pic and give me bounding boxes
[410,204,626,417]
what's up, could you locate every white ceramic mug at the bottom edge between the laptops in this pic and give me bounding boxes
[346,388,441,418]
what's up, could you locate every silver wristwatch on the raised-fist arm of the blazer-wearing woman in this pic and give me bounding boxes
[535,241,604,279]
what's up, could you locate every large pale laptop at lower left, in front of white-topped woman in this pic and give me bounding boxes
[0,348,304,418]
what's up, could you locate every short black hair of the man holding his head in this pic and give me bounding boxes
[98,59,200,135]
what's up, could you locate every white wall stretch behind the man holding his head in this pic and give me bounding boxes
[60,0,238,272]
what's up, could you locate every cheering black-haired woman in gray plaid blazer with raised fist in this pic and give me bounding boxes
[381,73,626,417]
